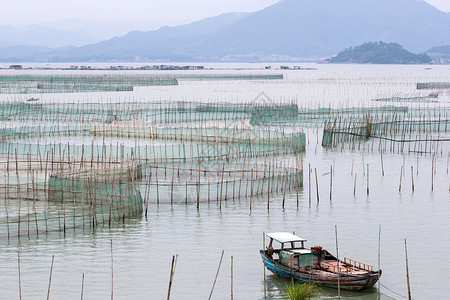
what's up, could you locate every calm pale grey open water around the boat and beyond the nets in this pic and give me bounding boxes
[0,66,450,299]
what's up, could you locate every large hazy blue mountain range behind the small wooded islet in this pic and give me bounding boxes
[0,0,450,61]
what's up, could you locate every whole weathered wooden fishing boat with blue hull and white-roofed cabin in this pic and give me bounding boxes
[260,232,381,291]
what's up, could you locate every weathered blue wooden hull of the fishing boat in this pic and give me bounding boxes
[260,251,381,291]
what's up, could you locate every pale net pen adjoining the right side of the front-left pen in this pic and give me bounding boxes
[136,159,303,204]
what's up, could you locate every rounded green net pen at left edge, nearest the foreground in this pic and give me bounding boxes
[0,164,143,238]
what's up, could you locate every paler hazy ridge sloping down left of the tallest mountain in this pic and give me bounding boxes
[40,13,247,61]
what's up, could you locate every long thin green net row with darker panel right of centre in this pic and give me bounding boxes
[0,101,413,127]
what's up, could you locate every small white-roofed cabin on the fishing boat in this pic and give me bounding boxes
[267,232,318,269]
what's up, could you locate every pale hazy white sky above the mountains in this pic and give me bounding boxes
[0,0,450,26]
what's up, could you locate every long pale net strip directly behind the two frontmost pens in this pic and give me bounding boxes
[0,134,306,164]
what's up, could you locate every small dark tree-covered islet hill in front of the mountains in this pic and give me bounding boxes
[330,42,431,64]
